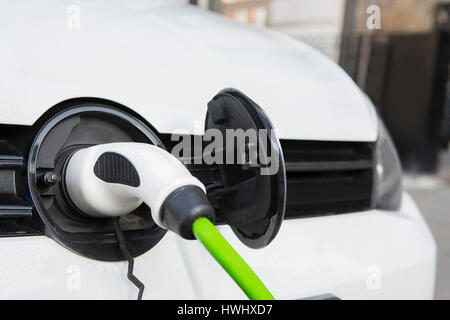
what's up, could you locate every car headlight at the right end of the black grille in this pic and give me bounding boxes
[374,119,402,210]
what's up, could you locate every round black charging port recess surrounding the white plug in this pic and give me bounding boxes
[28,102,166,261]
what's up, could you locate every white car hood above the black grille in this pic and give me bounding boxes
[0,0,377,141]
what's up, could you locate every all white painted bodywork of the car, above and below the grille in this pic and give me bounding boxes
[0,0,436,299]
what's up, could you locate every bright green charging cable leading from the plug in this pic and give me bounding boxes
[192,218,274,300]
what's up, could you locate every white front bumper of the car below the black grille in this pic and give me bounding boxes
[0,194,436,299]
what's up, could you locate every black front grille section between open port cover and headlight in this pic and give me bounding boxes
[281,140,373,218]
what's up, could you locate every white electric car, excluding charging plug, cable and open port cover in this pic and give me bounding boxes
[0,0,436,299]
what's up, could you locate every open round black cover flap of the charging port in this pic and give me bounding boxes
[205,88,286,248]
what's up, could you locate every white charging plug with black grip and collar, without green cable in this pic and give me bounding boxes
[64,142,214,239]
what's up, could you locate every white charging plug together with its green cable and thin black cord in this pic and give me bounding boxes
[63,142,273,299]
